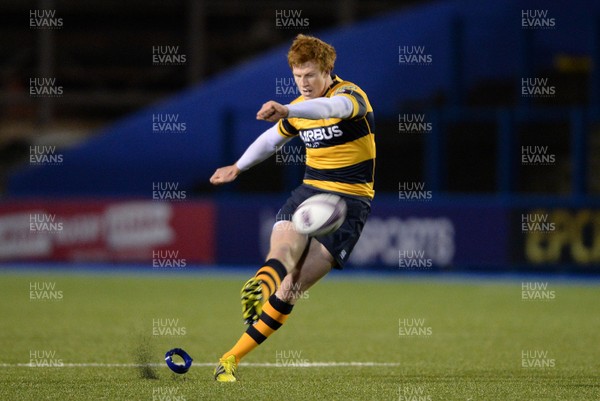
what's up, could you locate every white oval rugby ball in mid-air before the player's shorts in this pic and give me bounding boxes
[292,194,346,237]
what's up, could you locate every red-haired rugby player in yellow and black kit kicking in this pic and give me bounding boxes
[210,34,375,382]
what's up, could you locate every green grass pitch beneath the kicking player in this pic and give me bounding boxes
[0,270,600,401]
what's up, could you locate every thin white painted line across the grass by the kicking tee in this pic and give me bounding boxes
[0,362,400,368]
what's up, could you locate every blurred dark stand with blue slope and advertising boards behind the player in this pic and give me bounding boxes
[0,0,600,274]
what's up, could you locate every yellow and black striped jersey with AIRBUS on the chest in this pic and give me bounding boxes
[277,75,375,200]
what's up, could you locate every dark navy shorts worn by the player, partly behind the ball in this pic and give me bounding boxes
[276,185,371,269]
